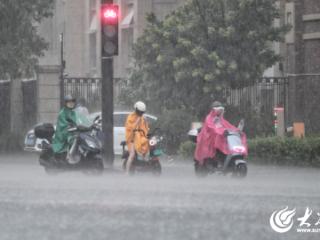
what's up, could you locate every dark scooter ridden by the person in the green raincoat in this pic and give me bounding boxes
[34,117,104,175]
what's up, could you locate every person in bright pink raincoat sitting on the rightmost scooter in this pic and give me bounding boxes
[194,101,245,165]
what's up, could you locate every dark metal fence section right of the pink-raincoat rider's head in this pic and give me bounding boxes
[224,77,289,136]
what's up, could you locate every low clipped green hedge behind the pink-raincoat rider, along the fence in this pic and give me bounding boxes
[179,137,320,167]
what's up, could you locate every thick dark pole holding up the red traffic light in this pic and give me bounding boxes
[101,0,114,168]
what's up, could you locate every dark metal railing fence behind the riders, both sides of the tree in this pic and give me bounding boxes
[63,77,288,136]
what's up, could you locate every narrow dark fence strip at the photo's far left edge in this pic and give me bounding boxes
[0,81,10,135]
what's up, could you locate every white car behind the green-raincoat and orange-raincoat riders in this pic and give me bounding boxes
[24,111,157,155]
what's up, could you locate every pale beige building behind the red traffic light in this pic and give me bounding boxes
[39,0,184,78]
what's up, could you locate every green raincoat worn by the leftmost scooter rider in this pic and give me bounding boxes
[52,107,77,153]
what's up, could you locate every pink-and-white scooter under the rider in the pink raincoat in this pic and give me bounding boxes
[188,120,248,178]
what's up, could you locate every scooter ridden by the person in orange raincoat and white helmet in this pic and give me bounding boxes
[121,129,163,176]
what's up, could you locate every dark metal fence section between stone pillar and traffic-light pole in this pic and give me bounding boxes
[63,77,101,111]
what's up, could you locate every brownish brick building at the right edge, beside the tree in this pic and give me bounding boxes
[280,0,320,127]
